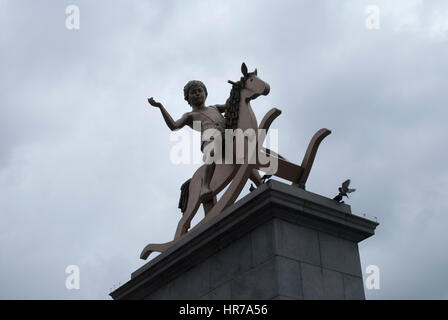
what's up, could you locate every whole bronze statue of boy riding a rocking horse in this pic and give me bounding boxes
[140,63,331,259]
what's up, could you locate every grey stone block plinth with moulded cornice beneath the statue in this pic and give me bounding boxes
[110,180,378,300]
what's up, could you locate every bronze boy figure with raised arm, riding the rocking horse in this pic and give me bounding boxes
[148,80,226,201]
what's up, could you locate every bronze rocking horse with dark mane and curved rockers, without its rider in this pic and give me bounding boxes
[140,63,331,259]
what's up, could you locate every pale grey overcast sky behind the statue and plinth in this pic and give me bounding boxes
[0,0,448,299]
